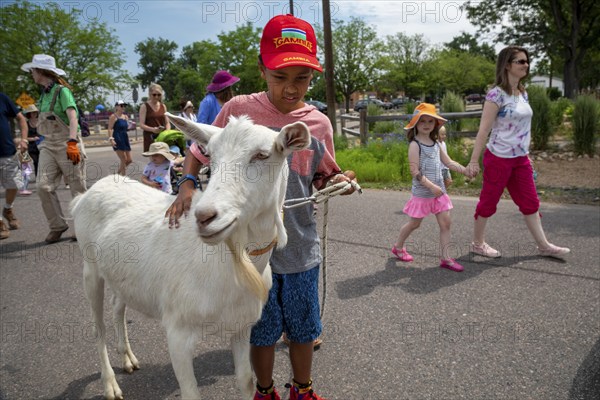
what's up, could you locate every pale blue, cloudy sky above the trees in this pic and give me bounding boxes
[38,0,488,100]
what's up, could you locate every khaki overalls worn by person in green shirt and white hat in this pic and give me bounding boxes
[36,113,87,231]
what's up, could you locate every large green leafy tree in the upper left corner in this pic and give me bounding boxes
[0,1,131,109]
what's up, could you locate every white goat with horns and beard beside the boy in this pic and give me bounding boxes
[71,114,310,399]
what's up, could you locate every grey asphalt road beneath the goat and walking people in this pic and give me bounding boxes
[0,144,600,400]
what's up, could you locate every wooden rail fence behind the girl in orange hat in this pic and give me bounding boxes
[340,109,481,145]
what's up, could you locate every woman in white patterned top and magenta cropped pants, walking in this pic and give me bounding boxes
[469,46,570,258]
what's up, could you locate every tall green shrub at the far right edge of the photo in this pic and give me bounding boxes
[572,96,600,155]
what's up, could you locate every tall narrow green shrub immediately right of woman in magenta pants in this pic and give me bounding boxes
[527,85,552,150]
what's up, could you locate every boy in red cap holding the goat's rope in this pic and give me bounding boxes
[166,15,354,400]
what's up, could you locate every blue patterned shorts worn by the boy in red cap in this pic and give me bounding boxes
[250,266,323,346]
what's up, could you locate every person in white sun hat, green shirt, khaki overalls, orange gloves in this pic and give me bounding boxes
[21,54,86,243]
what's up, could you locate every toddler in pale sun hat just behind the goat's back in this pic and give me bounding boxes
[142,142,175,194]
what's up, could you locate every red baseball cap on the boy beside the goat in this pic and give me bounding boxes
[260,14,323,72]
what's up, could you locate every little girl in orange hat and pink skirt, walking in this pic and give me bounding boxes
[392,103,474,272]
